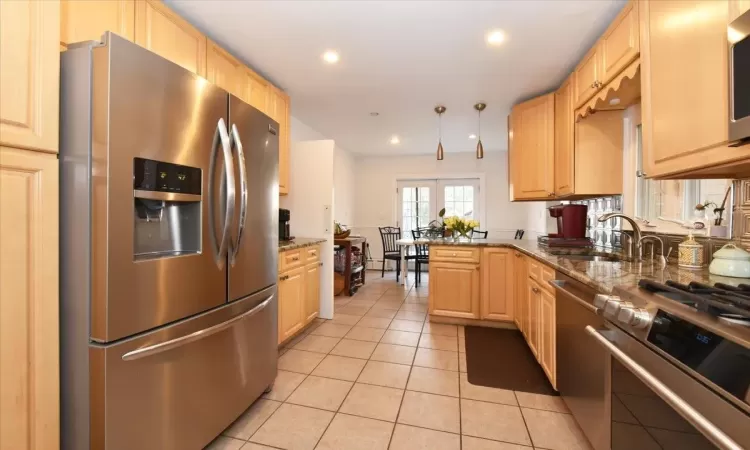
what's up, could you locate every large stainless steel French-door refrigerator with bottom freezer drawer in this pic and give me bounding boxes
[60,33,278,450]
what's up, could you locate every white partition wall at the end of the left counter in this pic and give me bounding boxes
[280,140,334,319]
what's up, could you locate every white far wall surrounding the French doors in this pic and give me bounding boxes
[354,152,546,267]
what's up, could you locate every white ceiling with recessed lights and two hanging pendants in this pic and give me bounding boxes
[167,0,625,155]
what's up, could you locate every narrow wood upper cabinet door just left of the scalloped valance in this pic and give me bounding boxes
[555,76,575,197]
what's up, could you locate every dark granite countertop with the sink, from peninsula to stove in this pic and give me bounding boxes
[412,239,750,293]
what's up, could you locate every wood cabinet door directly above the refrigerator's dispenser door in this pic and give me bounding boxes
[135,0,206,77]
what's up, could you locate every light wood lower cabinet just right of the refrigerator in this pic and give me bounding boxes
[277,246,321,344]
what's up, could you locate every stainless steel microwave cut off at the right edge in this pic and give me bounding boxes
[727,11,750,145]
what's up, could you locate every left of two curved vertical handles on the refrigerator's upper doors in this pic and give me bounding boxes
[208,118,234,269]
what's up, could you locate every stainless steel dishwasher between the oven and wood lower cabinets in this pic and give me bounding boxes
[550,272,612,450]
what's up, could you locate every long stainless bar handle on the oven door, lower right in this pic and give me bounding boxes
[586,325,743,450]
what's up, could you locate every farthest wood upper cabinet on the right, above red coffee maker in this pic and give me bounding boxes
[508,93,555,200]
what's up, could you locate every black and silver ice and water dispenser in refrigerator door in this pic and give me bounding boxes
[133,158,203,261]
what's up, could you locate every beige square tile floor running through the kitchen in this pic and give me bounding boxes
[207,272,590,450]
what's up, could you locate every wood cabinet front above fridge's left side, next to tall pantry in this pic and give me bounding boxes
[60,0,135,47]
